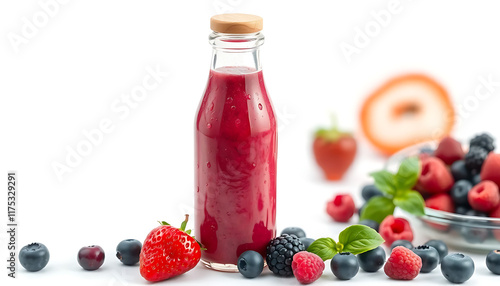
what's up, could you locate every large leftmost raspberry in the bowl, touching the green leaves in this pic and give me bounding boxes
[417,157,454,194]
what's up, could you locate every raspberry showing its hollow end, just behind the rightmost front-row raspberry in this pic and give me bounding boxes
[378,215,413,246]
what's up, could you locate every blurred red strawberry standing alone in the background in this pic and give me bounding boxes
[313,121,357,181]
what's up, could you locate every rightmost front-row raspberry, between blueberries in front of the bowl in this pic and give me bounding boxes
[384,246,422,280]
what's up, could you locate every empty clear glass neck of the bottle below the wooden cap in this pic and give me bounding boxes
[209,32,264,73]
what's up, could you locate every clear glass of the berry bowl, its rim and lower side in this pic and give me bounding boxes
[385,141,500,251]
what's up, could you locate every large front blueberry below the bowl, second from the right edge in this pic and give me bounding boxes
[441,253,474,283]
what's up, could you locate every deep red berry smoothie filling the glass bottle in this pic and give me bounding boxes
[195,67,277,264]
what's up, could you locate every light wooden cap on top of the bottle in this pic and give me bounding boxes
[210,13,263,34]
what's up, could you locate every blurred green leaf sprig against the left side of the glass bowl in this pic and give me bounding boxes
[360,157,425,223]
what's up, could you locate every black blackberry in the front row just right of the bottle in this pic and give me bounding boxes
[266,234,305,277]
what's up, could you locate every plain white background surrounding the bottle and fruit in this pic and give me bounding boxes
[0,0,500,285]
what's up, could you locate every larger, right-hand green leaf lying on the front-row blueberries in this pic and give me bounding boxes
[338,224,384,255]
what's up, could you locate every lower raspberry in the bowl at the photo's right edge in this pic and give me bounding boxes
[467,181,500,212]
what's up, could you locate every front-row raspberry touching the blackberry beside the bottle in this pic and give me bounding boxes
[292,251,325,284]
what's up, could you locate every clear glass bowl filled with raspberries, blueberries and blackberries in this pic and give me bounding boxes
[385,134,500,251]
